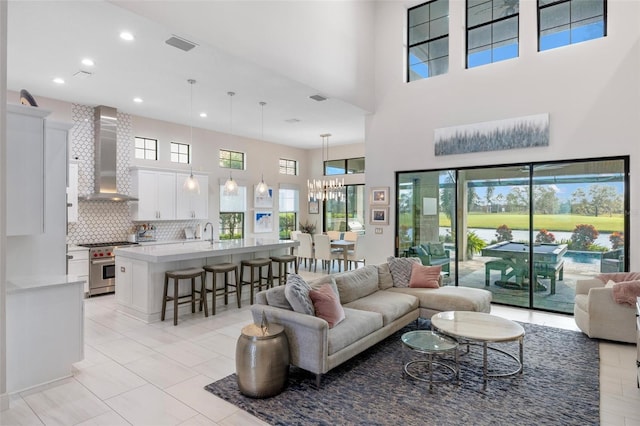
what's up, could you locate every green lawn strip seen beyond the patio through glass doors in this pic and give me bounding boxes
[440,213,624,232]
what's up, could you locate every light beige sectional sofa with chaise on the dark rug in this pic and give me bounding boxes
[251,263,491,386]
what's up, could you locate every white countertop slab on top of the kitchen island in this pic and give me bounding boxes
[115,238,300,263]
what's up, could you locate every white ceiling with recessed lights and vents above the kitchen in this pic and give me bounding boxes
[7,0,374,148]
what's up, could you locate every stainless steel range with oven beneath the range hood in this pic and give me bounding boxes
[80,241,137,296]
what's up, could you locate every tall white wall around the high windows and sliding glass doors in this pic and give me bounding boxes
[366,0,640,270]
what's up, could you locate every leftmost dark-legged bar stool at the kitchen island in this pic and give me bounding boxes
[160,268,209,325]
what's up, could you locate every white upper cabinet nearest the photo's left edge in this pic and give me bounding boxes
[5,104,49,236]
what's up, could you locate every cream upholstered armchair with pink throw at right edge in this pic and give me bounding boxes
[573,278,636,343]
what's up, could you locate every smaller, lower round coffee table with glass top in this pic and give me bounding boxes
[401,330,460,391]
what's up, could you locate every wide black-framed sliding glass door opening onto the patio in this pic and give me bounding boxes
[396,157,629,313]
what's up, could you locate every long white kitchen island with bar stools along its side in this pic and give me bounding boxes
[115,238,299,323]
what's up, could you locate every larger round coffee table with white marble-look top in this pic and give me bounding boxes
[431,311,524,389]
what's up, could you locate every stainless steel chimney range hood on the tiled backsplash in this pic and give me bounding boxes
[78,106,138,201]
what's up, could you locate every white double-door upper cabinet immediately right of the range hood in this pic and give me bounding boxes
[131,169,176,220]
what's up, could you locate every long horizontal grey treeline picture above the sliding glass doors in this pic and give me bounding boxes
[434,114,549,156]
